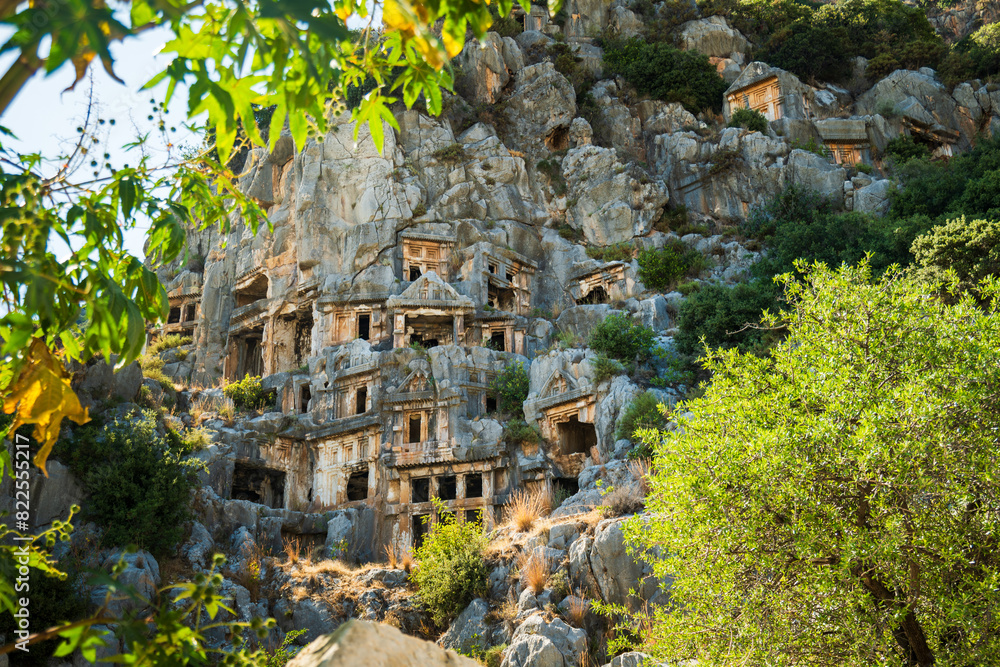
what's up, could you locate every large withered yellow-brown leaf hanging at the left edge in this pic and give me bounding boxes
[3,338,90,477]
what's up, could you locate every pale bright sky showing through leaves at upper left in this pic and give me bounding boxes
[0,29,198,264]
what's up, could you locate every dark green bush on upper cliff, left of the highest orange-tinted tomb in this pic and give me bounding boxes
[604,38,728,113]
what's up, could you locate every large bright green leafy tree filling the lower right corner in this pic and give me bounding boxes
[626,265,1000,665]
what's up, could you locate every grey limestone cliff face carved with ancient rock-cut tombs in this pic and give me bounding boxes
[146,0,1000,553]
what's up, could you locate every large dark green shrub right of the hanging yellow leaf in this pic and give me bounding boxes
[65,411,199,555]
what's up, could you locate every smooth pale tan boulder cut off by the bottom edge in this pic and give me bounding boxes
[288,619,478,667]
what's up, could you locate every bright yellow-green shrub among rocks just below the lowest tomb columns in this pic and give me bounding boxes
[410,501,490,625]
